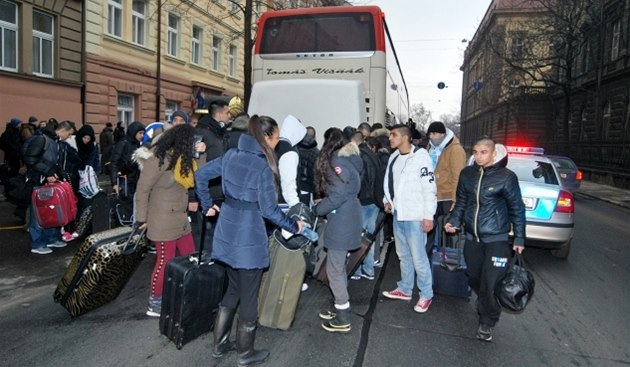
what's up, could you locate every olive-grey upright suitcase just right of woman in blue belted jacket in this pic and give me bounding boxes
[258,233,306,330]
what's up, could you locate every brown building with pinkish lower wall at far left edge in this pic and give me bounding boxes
[0,0,84,122]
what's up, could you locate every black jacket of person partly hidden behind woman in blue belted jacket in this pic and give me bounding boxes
[196,115,229,204]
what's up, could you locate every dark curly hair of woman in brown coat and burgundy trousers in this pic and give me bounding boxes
[153,124,195,177]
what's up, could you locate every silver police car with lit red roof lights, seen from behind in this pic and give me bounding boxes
[506,146,575,259]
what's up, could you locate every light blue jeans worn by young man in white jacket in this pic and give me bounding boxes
[394,212,433,299]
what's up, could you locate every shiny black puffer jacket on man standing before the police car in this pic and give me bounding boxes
[449,156,525,246]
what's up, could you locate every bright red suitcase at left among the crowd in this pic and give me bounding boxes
[31,181,77,228]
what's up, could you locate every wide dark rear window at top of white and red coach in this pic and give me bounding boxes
[260,13,376,54]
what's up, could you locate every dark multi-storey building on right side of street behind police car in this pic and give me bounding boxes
[461,0,630,187]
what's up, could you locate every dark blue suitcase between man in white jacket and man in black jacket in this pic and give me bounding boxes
[431,216,471,299]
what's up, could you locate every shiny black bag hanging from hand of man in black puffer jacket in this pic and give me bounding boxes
[494,254,536,313]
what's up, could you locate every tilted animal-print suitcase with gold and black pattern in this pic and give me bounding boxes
[53,227,147,316]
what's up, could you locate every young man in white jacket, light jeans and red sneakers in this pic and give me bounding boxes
[383,125,437,313]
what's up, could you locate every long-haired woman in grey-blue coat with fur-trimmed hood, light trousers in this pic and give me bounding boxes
[314,128,363,333]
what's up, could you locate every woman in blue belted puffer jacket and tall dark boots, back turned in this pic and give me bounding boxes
[195,115,304,366]
